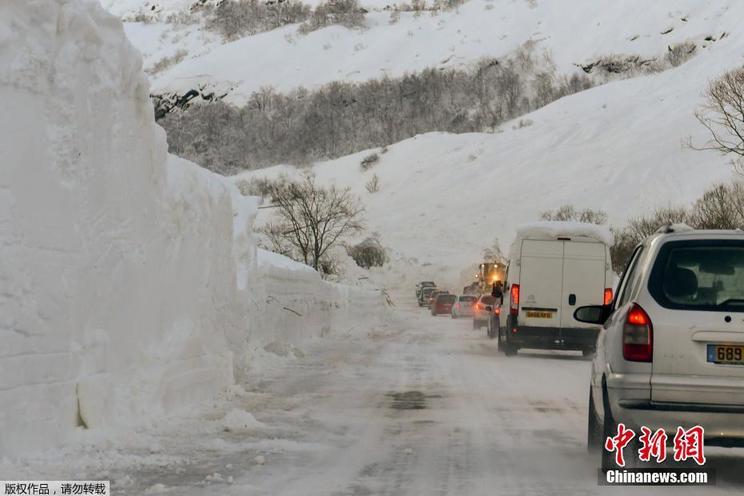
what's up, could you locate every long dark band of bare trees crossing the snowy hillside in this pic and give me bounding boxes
[158,54,591,174]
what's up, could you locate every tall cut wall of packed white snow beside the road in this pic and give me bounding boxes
[0,0,383,456]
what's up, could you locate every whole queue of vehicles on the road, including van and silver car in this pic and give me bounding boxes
[416,222,744,469]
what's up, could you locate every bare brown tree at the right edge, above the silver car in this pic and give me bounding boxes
[689,68,744,172]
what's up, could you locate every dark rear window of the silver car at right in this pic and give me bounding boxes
[649,240,744,312]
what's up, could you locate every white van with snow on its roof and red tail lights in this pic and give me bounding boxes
[491,221,615,355]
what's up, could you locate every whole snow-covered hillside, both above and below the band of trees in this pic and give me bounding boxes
[104,0,744,285]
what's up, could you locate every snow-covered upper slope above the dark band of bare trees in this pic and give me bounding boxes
[113,0,744,103]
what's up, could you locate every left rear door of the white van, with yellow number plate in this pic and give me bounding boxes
[519,239,563,328]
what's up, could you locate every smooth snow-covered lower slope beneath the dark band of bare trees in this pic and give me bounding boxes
[242,26,744,285]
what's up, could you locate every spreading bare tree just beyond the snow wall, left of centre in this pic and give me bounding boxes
[263,176,363,272]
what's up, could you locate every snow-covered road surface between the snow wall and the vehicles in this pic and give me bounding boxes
[10,296,744,495]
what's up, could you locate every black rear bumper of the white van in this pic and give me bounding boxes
[506,326,599,350]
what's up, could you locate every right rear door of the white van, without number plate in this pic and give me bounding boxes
[561,241,607,328]
